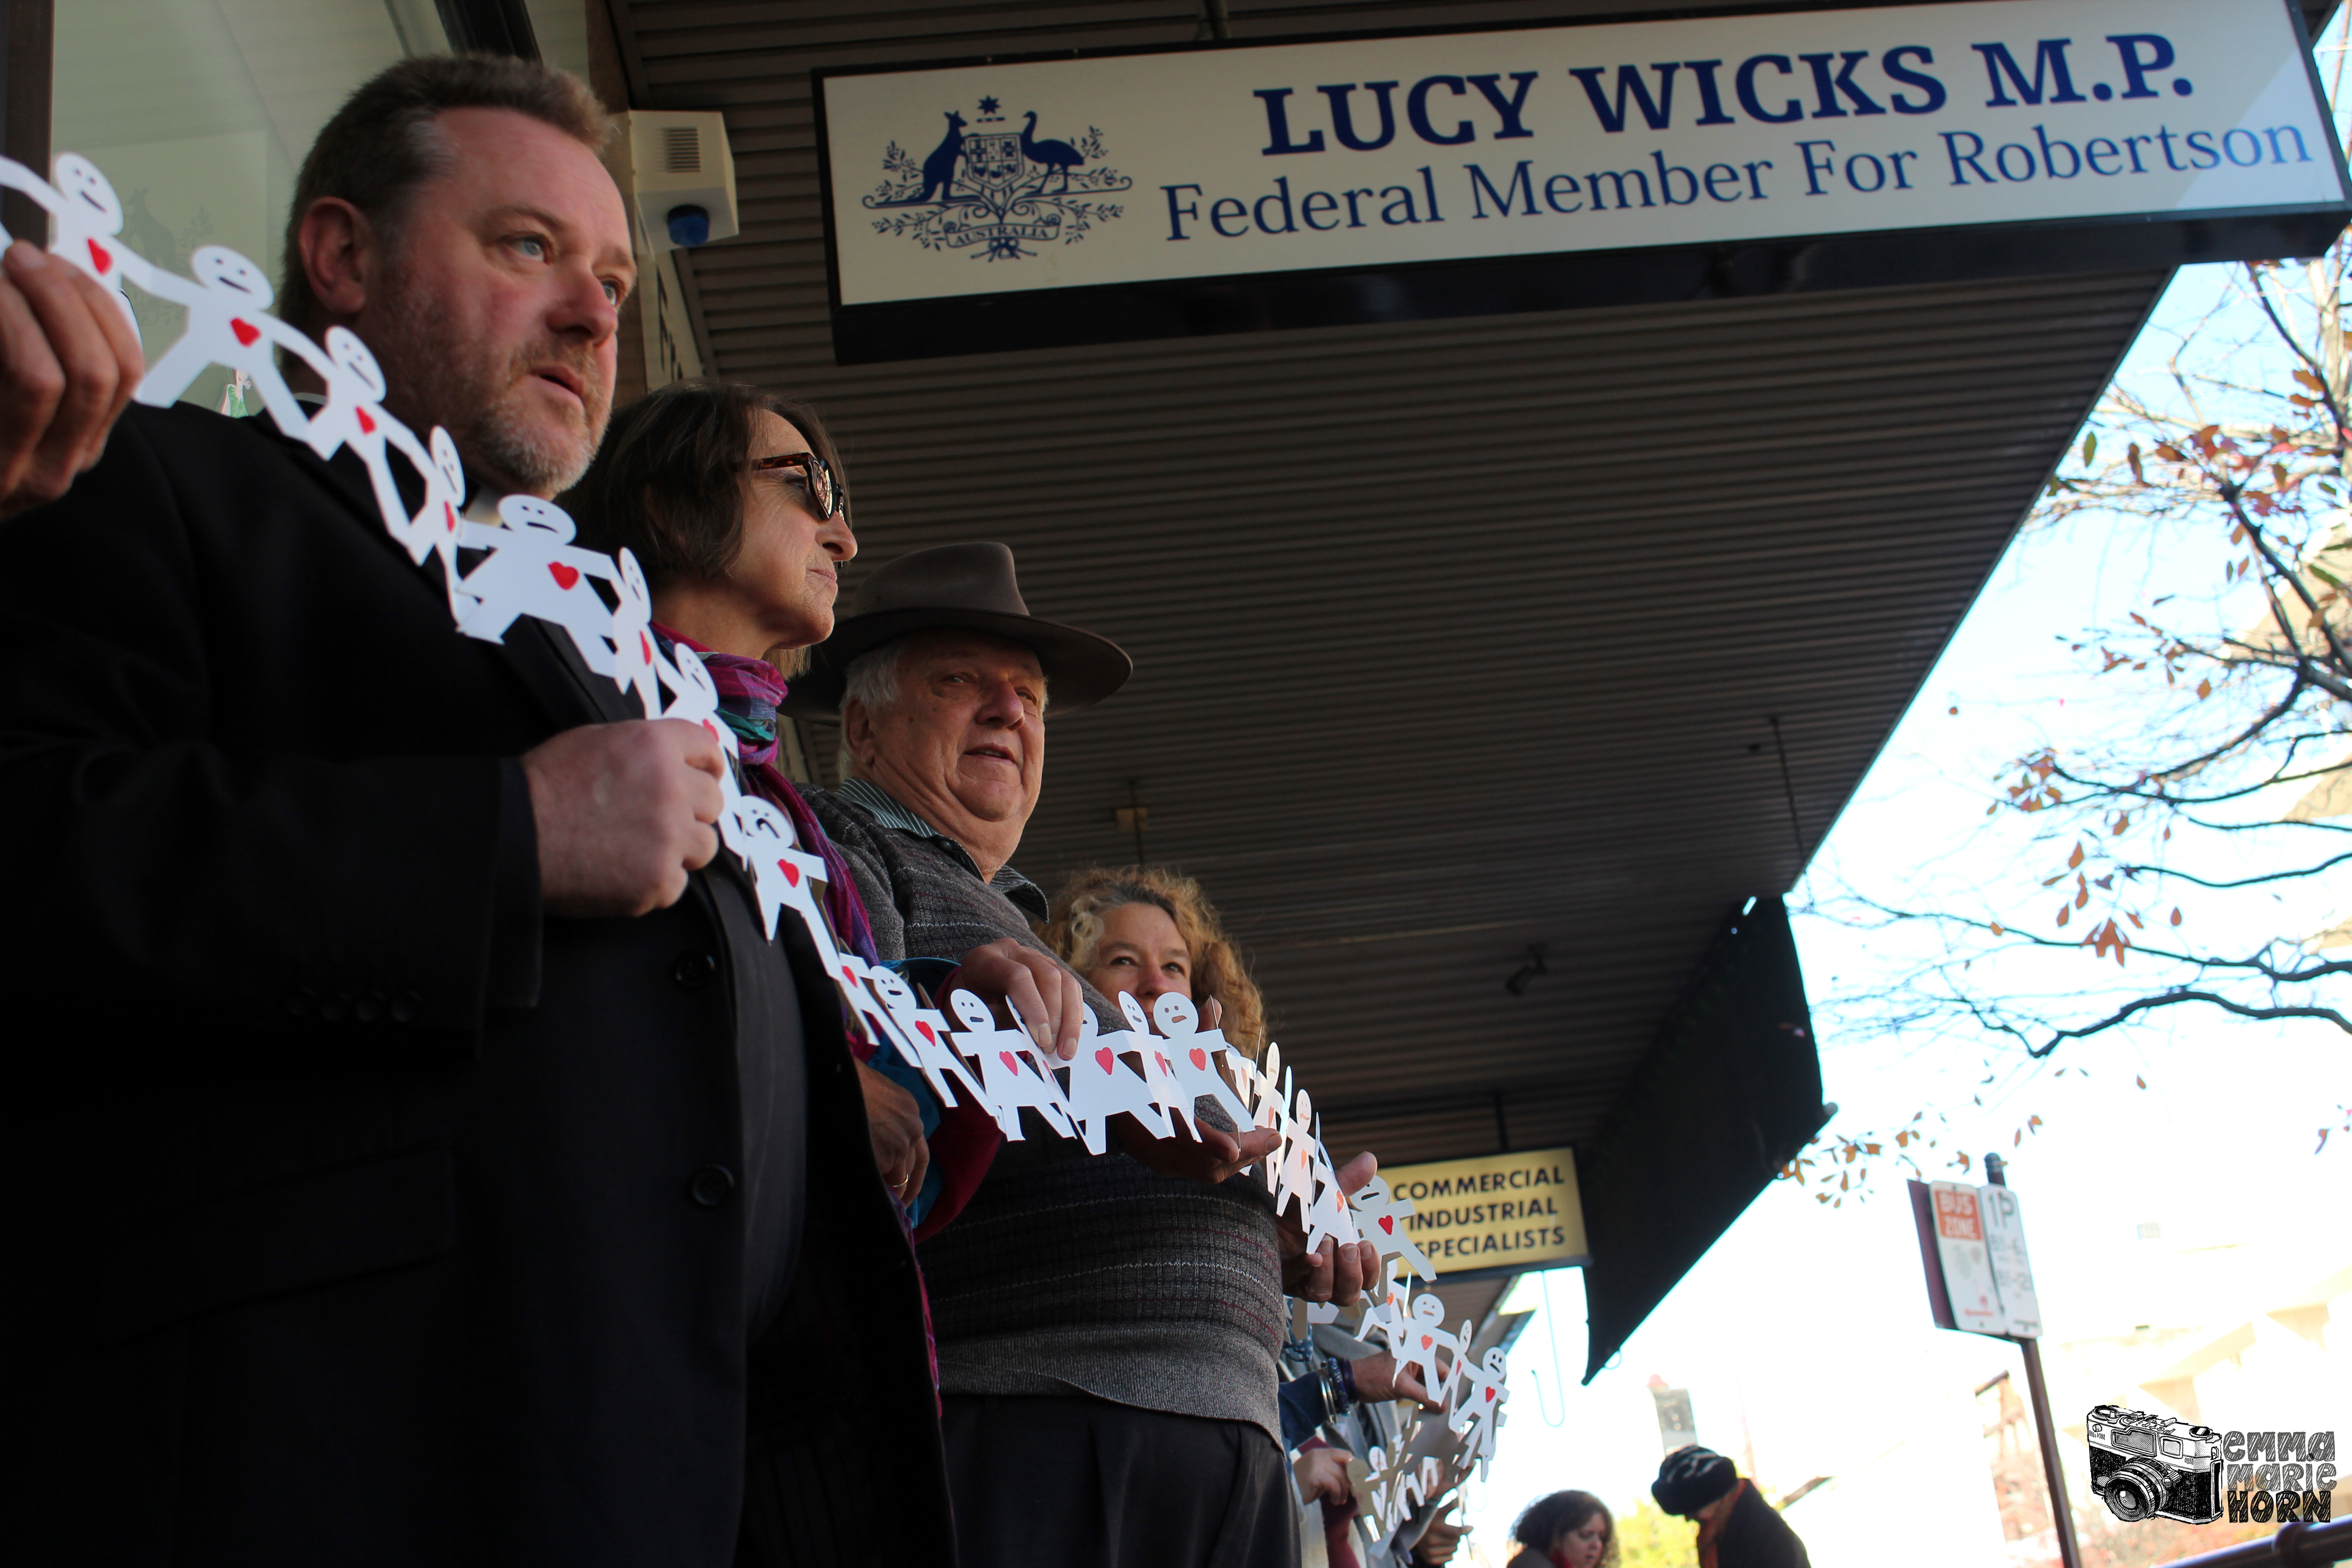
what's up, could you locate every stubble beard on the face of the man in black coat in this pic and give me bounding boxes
[369,267,612,496]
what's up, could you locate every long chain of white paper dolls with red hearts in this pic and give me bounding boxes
[0,153,1508,1495]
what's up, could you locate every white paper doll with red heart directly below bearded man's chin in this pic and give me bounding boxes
[456,496,625,672]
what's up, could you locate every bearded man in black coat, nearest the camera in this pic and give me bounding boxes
[0,56,1030,1568]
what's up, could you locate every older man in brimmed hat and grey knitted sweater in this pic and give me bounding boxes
[788,543,1376,1568]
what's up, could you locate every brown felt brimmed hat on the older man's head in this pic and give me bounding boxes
[781,545,1136,720]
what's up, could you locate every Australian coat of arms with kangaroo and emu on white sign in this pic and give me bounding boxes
[866,99,1134,261]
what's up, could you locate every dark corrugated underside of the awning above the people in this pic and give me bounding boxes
[616,0,2164,1161]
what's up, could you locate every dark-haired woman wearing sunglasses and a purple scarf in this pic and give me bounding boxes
[567,381,1020,1568]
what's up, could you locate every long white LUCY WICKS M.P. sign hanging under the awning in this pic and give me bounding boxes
[816,0,2352,360]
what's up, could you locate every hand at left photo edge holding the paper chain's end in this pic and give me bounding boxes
[0,240,146,517]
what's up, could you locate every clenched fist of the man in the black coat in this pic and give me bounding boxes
[522,720,727,917]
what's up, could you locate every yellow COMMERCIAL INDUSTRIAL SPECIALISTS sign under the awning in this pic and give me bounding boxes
[1381,1150,1585,1274]
